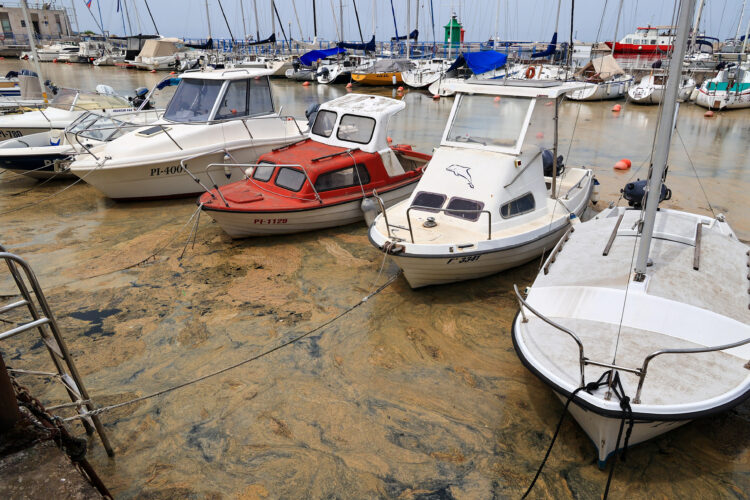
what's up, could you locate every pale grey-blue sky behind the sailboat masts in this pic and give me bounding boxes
[70,0,750,42]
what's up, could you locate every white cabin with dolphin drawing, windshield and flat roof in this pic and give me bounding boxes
[410,81,584,227]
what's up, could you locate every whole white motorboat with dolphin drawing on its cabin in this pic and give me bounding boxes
[369,81,594,288]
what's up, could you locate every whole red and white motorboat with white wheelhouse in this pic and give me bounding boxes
[199,94,431,242]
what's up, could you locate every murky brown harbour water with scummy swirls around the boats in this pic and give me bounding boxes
[0,60,750,499]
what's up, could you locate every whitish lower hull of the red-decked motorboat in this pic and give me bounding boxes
[203,179,418,239]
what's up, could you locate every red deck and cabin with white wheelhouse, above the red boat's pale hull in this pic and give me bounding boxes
[201,94,430,210]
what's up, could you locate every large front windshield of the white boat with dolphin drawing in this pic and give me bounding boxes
[445,94,531,148]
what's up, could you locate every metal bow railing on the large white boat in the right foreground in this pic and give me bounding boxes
[513,285,750,404]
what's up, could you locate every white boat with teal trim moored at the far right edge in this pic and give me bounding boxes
[695,65,750,110]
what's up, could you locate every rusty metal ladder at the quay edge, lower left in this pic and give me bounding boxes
[0,245,114,457]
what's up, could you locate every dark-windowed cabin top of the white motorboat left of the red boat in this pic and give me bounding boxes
[164,68,275,123]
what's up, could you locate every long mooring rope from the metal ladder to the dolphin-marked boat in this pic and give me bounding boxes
[61,270,401,422]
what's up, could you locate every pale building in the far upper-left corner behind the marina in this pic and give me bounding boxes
[0,2,74,44]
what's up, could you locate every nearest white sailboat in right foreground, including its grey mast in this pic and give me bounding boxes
[512,0,750,472]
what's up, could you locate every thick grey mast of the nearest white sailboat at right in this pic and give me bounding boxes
[635,0,695,281]
